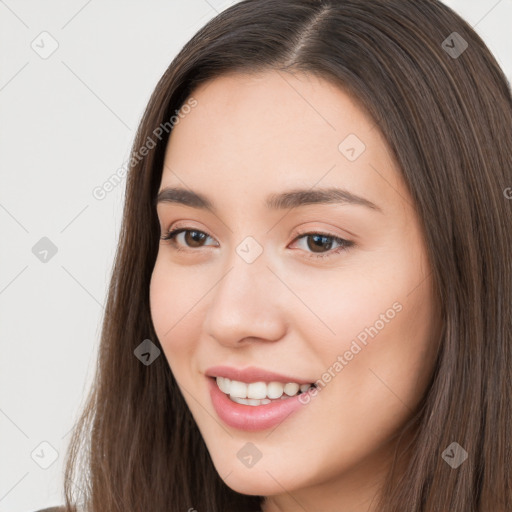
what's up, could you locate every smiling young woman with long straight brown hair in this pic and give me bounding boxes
[40,0,512,512]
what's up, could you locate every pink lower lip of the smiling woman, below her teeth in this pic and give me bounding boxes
[208,377,316,431]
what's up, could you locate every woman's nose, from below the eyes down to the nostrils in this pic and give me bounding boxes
[203,249,290,347]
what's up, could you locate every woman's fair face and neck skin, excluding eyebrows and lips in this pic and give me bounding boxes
[150,71,439,512]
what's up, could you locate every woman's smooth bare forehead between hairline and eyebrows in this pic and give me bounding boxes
[162,71,407,216]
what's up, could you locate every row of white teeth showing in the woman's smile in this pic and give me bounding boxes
[216,377,312,405]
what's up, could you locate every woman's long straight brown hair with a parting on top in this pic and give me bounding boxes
[65,0,512,512]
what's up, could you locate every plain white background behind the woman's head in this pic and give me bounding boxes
[0,0,512,512]
